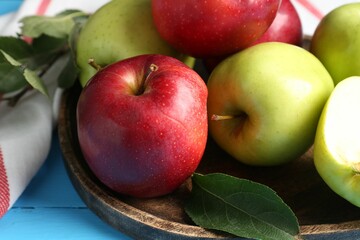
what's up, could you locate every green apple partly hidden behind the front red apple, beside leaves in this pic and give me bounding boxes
[76,0,195,86]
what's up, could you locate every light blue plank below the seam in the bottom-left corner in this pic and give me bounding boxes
[0,208,130,240]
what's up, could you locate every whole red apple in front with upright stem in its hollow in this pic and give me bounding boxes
[77,55,208,197]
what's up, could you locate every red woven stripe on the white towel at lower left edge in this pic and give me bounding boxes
[0,147,10,217]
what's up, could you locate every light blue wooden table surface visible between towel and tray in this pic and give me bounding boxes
[0,132,131,240]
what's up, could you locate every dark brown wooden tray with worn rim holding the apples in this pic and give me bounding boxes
[58,64,360,240]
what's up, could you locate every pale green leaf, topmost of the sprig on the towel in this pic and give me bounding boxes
[20,10,86,38]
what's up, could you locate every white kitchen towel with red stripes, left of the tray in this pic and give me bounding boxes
[0,0,107,218]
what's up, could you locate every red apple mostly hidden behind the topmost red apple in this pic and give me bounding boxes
[251,0,303,46]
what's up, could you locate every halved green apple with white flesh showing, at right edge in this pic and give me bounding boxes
[314,76,360,207]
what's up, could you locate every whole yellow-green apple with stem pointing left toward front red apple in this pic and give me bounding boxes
[207,42,334,166]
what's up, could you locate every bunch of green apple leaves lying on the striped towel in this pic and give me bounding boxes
[0,10,83,102]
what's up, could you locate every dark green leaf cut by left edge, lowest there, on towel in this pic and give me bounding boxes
[0,50,27,93]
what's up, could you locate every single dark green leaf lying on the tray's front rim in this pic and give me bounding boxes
[185,173,300,240]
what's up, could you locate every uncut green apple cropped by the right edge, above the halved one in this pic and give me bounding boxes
[310,2,360,85]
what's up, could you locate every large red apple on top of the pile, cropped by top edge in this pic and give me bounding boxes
[152,0,281,58]
